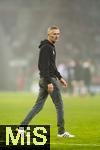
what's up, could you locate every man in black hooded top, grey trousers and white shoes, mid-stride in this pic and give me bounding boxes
[17,26,74,137]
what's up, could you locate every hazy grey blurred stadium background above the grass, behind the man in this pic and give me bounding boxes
[0,0,100,94]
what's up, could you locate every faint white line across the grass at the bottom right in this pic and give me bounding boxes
[50,143,100,147]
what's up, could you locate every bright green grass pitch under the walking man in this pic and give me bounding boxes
[0,92,100,150]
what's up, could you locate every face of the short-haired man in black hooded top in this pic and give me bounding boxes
[48,29,60,43]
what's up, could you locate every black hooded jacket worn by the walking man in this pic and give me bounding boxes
[38,39,62,84]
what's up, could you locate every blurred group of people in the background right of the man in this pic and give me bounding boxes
[58,60,97,96]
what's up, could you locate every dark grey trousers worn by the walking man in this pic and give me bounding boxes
[21,78,65,134]
